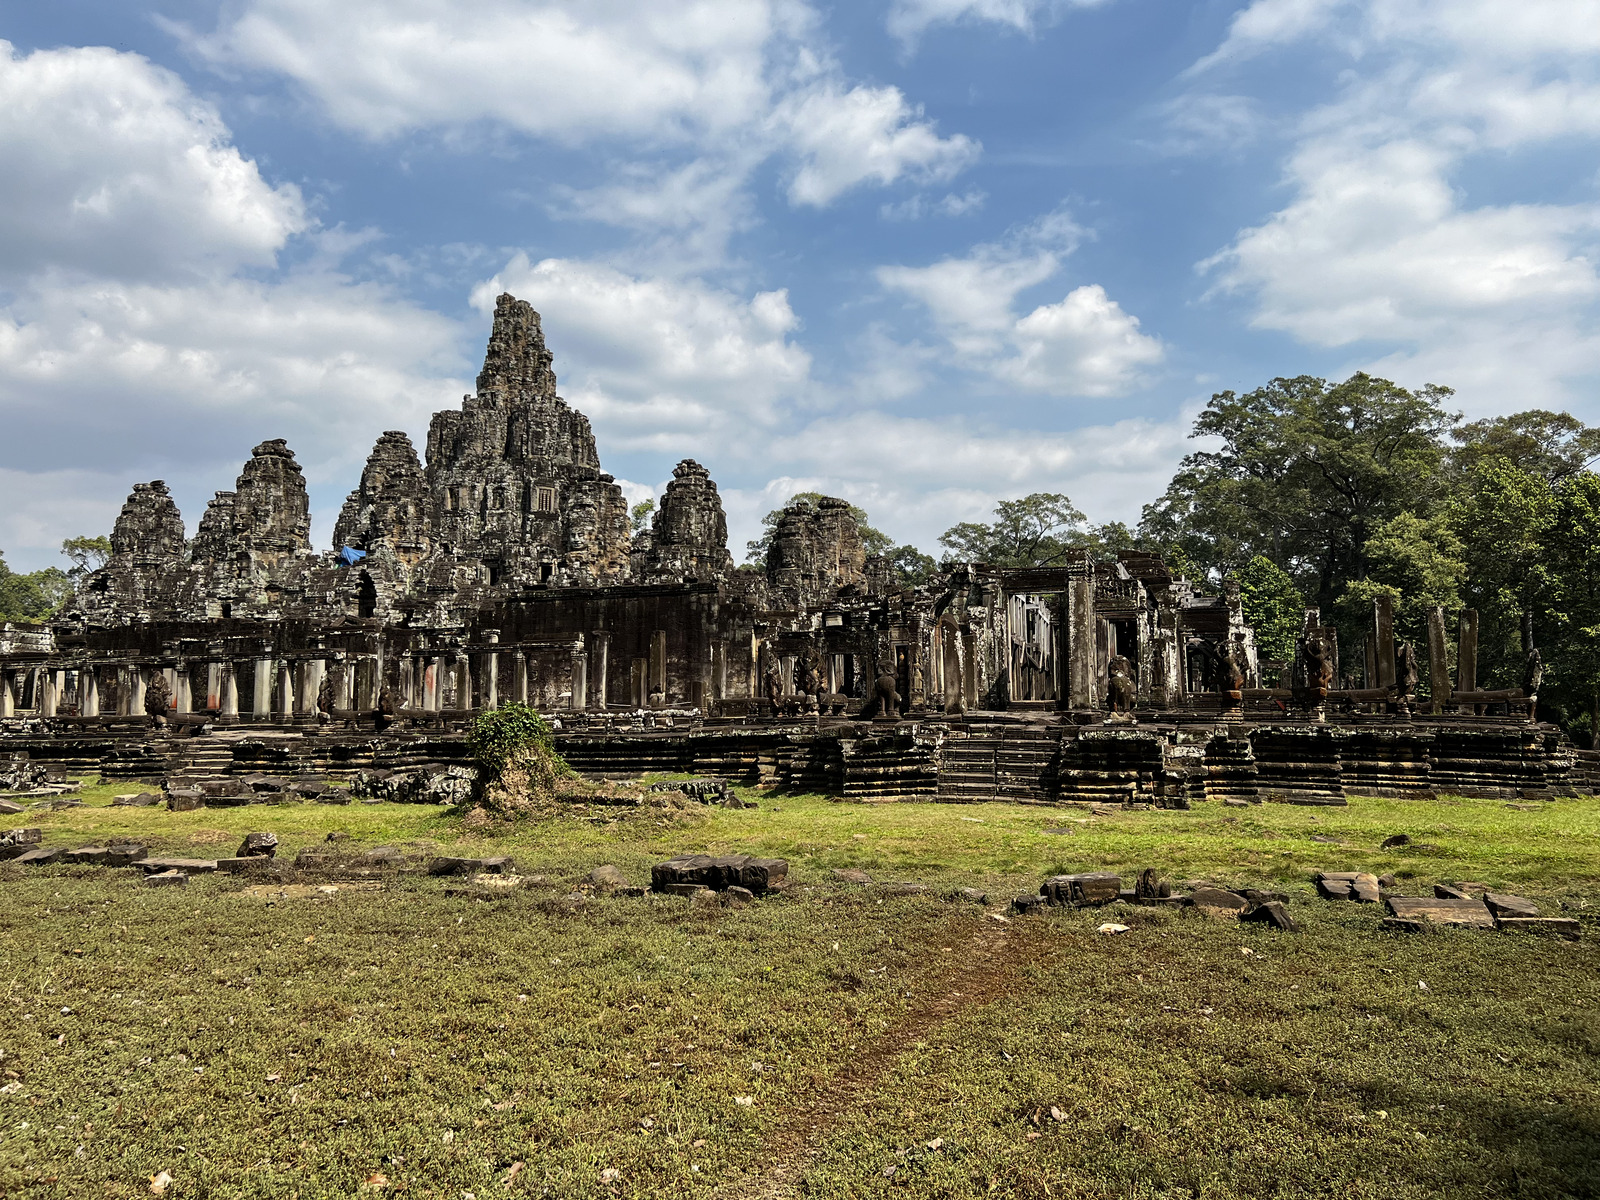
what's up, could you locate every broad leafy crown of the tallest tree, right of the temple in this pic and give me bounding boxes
[1139,373,1454,610]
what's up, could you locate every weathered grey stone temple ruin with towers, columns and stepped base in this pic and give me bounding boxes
[0,296,1597,806]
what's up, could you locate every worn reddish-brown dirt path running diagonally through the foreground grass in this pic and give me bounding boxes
[717,918,1048,1200]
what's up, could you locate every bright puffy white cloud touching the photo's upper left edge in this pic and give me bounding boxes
[0,42,307,278]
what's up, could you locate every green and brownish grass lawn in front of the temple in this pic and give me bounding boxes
[0,787,1600,1200]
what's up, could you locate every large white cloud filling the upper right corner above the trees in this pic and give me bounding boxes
[1200,0,1600,410]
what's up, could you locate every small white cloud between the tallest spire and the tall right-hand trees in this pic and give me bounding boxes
[877,214,1165,395]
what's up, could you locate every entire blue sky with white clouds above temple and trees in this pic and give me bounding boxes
[0,0,1600,568]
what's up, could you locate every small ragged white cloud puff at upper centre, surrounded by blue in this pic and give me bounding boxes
[776,83,979,208]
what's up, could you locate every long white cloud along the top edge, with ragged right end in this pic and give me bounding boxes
[181,0,979,244]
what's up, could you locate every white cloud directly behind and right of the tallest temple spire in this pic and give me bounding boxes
[472,254,811,453]
